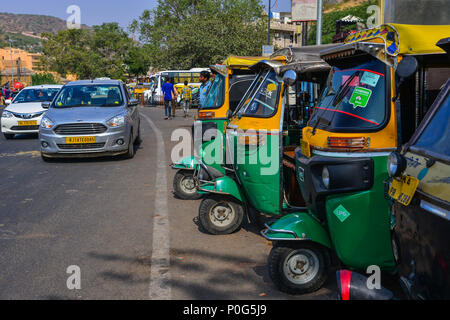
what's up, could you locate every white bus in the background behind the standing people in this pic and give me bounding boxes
[144,68,210,104]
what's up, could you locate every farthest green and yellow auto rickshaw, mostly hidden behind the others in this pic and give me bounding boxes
[172,56,264,200]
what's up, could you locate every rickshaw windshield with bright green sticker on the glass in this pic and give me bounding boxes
[309,59,386,131]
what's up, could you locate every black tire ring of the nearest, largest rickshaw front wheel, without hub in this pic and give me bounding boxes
[268,240,328,295]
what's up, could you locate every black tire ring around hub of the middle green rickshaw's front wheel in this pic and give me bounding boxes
[199,195,245,235]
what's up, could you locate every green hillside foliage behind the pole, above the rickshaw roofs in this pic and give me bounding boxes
[308,0,379,45]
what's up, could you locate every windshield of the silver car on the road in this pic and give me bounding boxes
[54,85,123,108]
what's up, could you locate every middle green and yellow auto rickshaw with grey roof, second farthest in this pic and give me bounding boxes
[196,46,331,235]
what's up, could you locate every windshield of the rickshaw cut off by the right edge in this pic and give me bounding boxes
[414,94,450,158]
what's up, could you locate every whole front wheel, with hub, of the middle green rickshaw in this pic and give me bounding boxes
[199,195,244,235]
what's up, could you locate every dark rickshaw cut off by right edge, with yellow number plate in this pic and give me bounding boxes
[336,38,450,300]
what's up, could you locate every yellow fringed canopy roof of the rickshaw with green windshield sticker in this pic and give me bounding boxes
[345,23,450,56]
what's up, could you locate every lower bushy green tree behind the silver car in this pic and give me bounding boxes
[38,23,149,79]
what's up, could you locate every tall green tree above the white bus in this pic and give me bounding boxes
[131,0,266,69]
